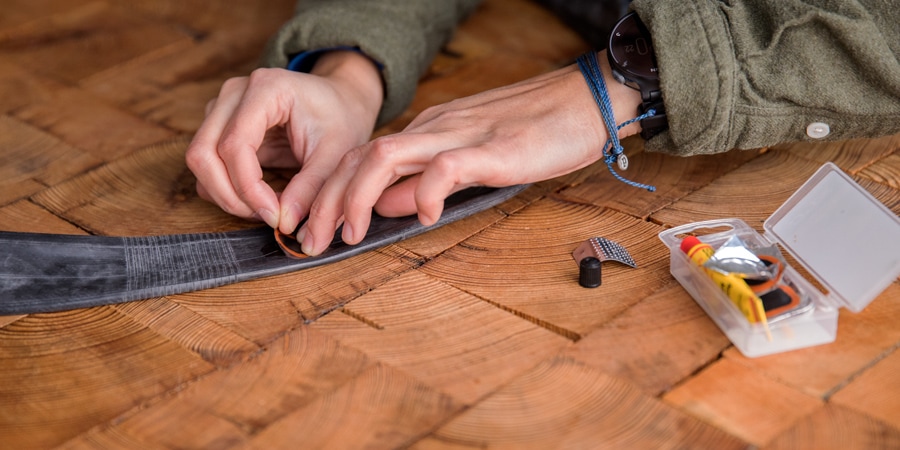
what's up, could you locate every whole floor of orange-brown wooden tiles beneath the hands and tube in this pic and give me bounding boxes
[0,0,900,449]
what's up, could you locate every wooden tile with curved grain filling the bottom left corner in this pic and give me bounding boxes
[0,308,213,448]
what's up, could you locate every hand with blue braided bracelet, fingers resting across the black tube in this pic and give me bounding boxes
[297,50,640,255]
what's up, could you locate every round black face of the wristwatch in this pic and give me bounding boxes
[609,13,659,79]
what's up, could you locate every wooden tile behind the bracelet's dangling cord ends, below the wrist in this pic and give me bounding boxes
[559,146,757,218]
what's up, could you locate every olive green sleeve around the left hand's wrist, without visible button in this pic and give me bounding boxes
[262,0,480,124]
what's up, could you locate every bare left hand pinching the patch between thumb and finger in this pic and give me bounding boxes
[185,51,383,233]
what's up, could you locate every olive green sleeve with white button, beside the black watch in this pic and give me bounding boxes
[632,0,900,155]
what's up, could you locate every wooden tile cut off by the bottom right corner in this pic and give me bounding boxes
[763,404,900,450]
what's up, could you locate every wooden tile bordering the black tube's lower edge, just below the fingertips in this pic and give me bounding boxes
[171,249,410,344]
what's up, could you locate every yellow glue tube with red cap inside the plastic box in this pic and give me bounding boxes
[681,236,772,340]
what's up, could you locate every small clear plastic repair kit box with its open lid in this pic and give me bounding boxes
[659,163,900,357]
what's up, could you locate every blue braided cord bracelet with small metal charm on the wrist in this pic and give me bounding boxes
[578,51,656,192]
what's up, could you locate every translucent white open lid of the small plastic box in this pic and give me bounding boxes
[763,162,900,312]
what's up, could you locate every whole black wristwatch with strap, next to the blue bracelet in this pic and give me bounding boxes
[607,12,669,139]
